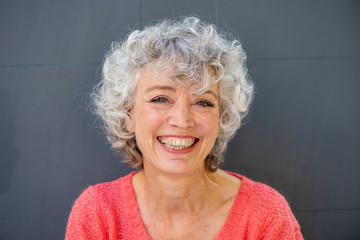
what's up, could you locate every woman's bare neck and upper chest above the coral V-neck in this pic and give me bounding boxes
[133,167,241,240]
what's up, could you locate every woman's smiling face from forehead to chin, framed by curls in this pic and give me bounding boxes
[127,67,220,174]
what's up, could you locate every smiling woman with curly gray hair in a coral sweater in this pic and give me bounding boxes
[66,17,302,239]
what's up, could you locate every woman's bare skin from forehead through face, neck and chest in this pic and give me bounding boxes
[126,66,241,240]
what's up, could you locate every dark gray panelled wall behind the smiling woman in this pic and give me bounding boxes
[0,0,360,240]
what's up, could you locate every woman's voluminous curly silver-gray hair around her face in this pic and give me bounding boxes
[93,17,253,171]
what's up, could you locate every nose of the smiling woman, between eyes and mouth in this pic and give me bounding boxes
[169,98,195,129]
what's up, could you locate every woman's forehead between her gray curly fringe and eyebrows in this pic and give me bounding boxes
[136,66,219,94]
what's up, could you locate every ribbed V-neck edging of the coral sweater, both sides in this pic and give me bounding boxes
[122,171,249,240]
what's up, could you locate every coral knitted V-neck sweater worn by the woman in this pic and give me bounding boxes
[65,172,303,240]
